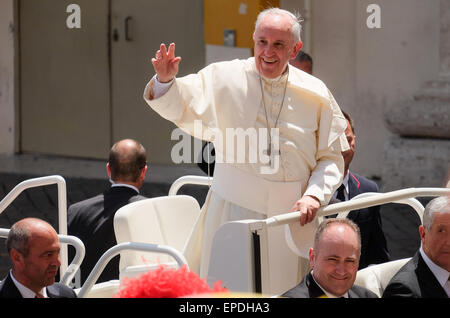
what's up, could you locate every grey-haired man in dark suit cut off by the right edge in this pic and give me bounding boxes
[383,196,450,298]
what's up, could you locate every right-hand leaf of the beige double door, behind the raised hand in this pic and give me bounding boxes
[111,0,205,164]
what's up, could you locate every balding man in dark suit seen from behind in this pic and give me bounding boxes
[68,139,147,284]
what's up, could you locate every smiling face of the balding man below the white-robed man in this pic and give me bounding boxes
[309,223,360,296]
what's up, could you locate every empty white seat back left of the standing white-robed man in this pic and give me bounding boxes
[114,195,200,278]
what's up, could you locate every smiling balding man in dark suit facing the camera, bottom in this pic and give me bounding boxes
[282,218,377,298]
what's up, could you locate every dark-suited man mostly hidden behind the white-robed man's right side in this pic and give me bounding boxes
[334,111,389,269]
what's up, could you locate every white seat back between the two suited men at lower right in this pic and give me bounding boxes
[355,258,411,297]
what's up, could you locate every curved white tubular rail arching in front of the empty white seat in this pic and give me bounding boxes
[78,242,189,298]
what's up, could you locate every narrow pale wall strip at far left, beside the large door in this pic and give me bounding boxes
[0,0,15,154]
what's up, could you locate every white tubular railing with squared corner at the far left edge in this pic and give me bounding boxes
[0,175,68,277]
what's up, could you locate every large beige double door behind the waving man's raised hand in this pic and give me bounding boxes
[8,0,205,164]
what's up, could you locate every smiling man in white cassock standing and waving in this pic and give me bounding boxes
[144,8,348,293]
